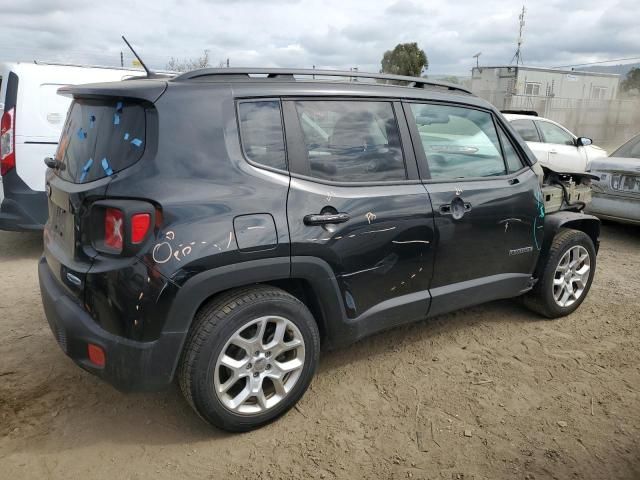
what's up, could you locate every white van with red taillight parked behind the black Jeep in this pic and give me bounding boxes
[0,63,145,231]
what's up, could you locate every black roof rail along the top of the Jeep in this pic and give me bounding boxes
[173,68,473,95]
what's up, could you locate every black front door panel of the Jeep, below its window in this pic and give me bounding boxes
[426,169,542,288]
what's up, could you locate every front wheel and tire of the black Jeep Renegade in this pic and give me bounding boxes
[523,229,596,318]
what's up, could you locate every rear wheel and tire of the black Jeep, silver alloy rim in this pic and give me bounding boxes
[178,285,320,432]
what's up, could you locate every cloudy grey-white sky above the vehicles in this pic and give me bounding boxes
[0,0,640,76]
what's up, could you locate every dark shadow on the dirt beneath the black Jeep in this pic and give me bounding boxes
[14,301,541,452]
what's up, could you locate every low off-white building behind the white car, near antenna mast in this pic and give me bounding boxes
[471,65,620,109]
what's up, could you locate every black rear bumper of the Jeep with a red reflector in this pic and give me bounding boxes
[38,257,185,391]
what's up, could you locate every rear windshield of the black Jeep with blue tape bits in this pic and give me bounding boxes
[56,99,146,183]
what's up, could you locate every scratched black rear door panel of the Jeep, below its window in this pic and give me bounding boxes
[287,178,433,318]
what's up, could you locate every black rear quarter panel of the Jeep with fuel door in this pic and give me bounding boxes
[85,83,290,339]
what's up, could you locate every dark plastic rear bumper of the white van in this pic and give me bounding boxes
[0,169,48,231]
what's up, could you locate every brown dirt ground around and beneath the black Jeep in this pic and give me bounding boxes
[0,224,640,480]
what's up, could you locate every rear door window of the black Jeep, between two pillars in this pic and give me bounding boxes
[295,100,407,182]
